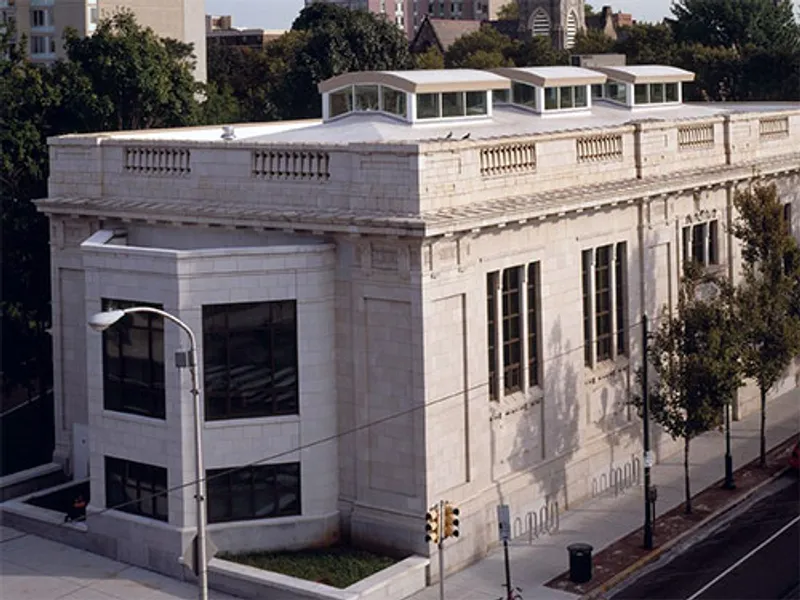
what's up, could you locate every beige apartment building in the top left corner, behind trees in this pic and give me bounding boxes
[0,0,206,81]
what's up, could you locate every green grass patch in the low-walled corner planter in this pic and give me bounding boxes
[222,546,397,588]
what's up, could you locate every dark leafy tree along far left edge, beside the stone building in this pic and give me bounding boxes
[0,27,61,397]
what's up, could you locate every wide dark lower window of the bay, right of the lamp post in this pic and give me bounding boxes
[206,462,301,523]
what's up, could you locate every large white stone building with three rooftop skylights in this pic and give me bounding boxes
[39,67,800,574]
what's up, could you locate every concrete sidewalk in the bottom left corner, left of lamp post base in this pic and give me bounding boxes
[0,526,234,600]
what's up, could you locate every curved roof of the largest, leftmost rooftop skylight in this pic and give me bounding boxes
[317,69,511,94]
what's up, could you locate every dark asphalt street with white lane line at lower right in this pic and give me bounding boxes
[611,474,800,600]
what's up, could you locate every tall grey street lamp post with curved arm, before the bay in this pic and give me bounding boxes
[89,306,208,600]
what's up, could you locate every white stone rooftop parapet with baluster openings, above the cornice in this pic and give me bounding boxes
[50,109,800,216]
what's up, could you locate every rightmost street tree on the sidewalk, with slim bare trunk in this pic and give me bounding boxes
[733,184,800,466]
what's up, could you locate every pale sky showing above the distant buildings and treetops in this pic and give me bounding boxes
[206,0,800,29]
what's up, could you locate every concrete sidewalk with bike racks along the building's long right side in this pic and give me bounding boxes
[409,389,800,600]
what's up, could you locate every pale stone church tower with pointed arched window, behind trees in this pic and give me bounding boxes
[517,0,586,50]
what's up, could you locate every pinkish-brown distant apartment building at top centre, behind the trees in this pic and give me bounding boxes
[306,0,507,40]
